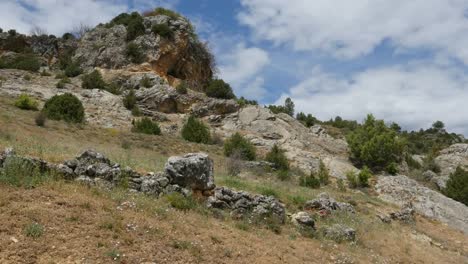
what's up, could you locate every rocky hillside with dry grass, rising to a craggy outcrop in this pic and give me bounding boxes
[0,9,468,263]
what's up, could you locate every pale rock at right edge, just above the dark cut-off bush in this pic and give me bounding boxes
[433,144,468,189]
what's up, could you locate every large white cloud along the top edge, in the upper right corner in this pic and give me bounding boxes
[238,0,468,64]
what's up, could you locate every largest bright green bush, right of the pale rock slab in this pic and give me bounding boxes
[346,115,404,170]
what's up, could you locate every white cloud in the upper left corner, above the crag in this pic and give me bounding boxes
[0,0,177,35]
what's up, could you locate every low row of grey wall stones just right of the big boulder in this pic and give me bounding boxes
[207,187,286,223]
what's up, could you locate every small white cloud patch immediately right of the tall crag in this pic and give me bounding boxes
[219,43,270,99]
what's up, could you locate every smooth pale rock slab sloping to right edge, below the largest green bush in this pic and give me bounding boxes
[376,176,468,234]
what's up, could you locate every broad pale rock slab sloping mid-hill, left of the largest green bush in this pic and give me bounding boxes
[217,106,357,179]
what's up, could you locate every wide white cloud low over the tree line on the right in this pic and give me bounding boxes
[277,61,468,134]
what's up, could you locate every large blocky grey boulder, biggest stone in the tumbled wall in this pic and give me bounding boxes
[165,153,216,191]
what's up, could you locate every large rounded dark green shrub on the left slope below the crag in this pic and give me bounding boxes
[42,93,85,123]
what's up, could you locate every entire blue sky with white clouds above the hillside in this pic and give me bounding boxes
[0,0,468,135]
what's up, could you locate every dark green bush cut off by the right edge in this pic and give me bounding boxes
[443,167,468,206]
